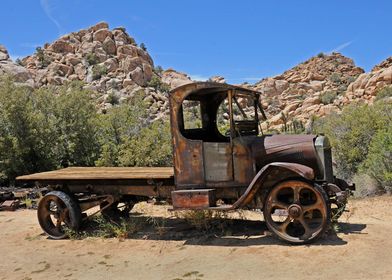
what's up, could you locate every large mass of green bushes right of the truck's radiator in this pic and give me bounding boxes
[313,99,392,195]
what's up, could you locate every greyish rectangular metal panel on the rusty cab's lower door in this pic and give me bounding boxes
[203,142,233,182]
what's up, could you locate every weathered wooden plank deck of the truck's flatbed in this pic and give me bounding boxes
[16,167,174,181]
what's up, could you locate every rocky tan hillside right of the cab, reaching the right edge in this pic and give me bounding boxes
[252,53,392,130]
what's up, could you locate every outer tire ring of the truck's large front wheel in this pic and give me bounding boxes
[263,180,331,245]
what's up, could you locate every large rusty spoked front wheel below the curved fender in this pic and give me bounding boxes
[264,180,330,244]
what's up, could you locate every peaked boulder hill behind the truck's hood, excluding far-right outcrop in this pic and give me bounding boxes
[253,53,364,130]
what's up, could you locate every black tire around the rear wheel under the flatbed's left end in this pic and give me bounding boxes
[37,191,82,240]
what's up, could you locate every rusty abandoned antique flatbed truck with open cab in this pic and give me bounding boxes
[17,82,354,243]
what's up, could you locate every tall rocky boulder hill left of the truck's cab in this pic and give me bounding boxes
[0,22,191,119]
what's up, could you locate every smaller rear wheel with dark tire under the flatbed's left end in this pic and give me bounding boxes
[37,191,82,239]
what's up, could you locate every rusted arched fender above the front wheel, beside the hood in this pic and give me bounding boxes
[232,162,314,209]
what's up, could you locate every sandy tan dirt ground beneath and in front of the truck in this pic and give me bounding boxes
[0,196,392,280]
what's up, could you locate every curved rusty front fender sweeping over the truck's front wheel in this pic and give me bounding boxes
[232,162,314,209]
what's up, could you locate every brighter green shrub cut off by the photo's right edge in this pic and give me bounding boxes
[360,126,392,193]
